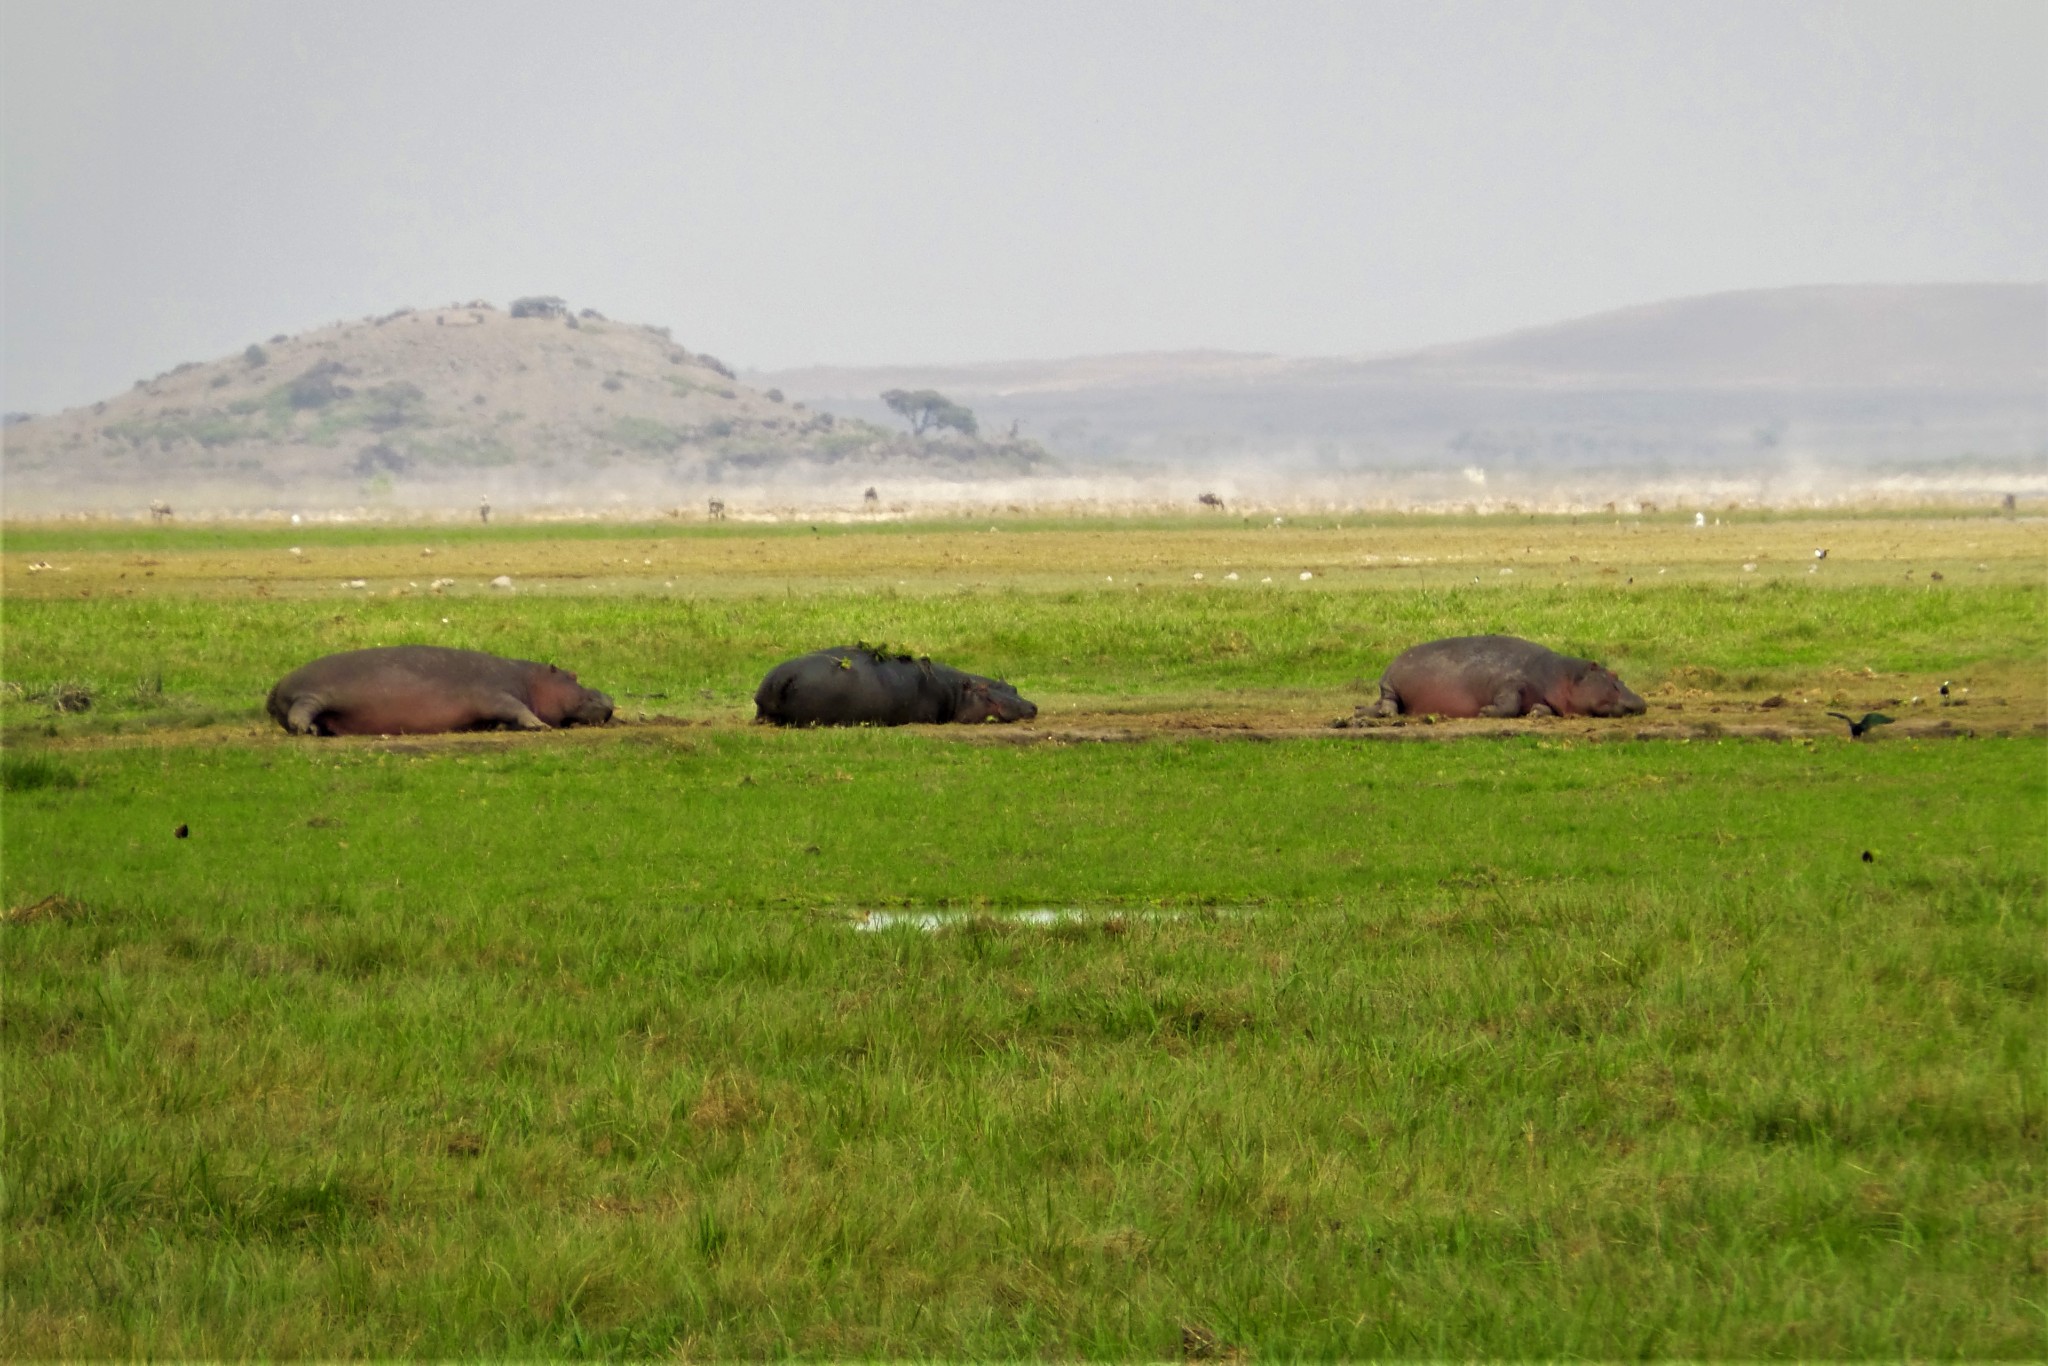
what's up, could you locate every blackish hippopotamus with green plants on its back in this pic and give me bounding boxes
[754,645,1038,725]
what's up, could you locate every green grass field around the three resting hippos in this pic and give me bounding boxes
[0,511,2048,1358]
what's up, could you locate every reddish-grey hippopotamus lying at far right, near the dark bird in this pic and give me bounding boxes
[1372,635,1647,717]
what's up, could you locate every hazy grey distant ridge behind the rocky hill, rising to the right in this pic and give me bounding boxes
[750,283,2048,477]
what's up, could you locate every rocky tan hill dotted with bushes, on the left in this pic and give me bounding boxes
[4,299,1044,516]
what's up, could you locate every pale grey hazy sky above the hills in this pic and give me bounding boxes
[0,0,2048,412]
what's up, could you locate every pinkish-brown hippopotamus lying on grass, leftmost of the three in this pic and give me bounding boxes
[268,645,612,735]
